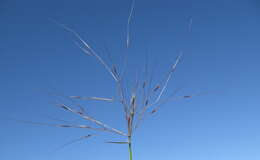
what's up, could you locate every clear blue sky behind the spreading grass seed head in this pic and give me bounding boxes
[0,0,260,160]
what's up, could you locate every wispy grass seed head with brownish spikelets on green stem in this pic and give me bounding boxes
[20,1,203,160]
